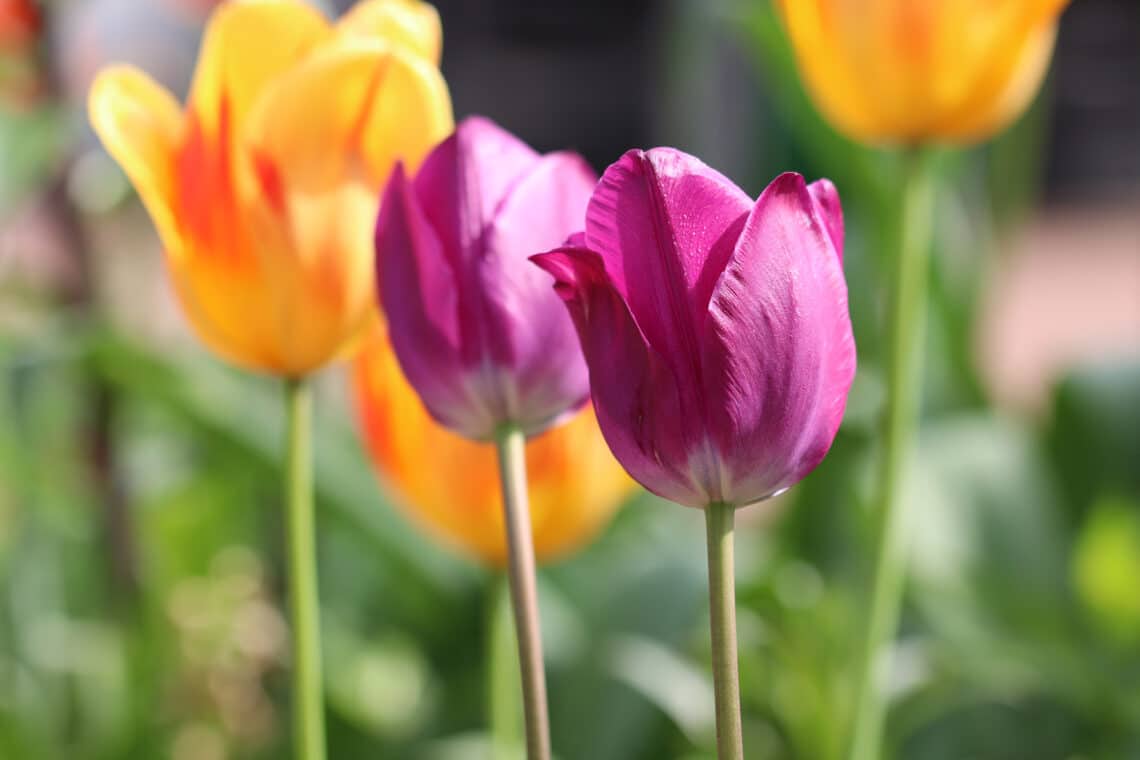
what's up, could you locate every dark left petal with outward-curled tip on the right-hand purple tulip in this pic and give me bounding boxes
[531,247,708,507]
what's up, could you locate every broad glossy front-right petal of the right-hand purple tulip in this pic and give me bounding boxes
[701,173,855,504]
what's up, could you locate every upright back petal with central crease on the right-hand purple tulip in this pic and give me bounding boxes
[586,148,751,387]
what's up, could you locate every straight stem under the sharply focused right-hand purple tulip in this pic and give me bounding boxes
[705,501,744,760]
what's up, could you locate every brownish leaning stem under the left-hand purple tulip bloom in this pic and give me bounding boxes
[495,426,551,760]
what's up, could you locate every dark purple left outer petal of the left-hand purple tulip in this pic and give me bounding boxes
[376,165,497,439]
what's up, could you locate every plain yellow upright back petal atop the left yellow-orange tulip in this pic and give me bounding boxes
[188,0,332,136]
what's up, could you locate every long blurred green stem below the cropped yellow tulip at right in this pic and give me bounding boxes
[850,149,934,760]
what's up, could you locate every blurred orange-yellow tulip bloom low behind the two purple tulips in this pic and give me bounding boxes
[353,330,635,566]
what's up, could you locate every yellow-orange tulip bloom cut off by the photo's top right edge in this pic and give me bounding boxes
[776,0,1067,144]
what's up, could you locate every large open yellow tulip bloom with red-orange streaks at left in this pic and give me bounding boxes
[89,0,453,377]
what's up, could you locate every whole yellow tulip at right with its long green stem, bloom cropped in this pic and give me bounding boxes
[776,0,1068,760]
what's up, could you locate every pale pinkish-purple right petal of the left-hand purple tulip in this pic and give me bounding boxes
[478,153,597,426]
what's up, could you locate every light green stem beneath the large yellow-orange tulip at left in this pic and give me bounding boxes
[285,379,325,760]
